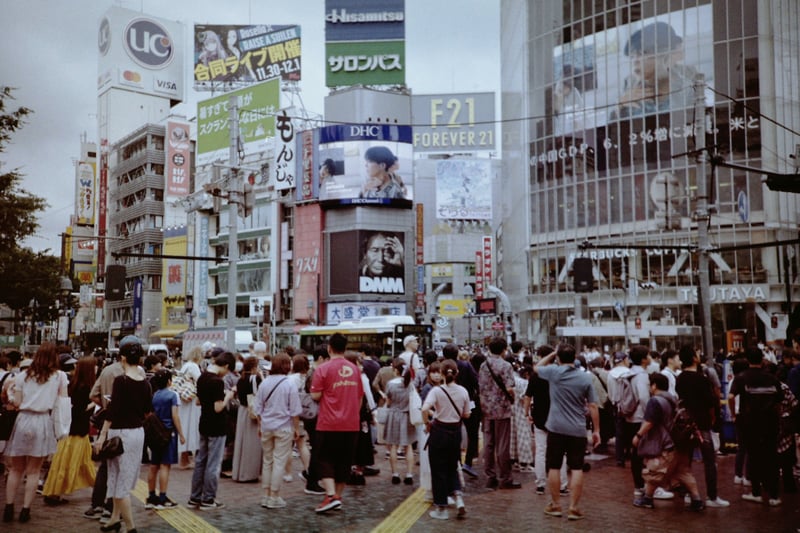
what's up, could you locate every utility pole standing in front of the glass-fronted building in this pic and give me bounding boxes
[694,74,714,364]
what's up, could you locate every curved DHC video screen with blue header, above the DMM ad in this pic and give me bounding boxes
[312,124,414,209]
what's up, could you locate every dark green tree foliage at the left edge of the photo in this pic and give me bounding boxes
[0,86,60,319]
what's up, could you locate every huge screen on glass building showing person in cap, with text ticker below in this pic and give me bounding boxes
[530,5,714,185]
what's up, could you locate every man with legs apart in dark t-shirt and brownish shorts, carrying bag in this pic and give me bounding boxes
[633,373,705,511]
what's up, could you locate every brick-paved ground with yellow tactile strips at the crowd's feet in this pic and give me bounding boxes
[0,450,800,533]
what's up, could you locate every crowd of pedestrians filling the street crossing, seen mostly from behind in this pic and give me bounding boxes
[0,333,800,531]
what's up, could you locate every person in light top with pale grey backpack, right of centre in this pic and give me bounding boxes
[617,344,652,498]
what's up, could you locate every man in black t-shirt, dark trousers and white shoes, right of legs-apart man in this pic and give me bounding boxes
[675,344,730,507]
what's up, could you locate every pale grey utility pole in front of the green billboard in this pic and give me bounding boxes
[225,95,242,353]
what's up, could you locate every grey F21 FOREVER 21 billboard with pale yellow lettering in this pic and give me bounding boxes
[411,93,495,152]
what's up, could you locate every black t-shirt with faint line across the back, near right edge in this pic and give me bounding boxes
[731,368,783,428]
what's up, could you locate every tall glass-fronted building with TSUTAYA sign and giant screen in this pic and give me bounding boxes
[497,0,800,348]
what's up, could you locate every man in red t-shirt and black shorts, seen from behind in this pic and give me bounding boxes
[311,333,364,513]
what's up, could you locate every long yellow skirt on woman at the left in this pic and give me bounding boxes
[42,435,96,496]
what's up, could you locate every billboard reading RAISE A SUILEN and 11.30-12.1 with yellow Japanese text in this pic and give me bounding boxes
[194,24,301,90]
